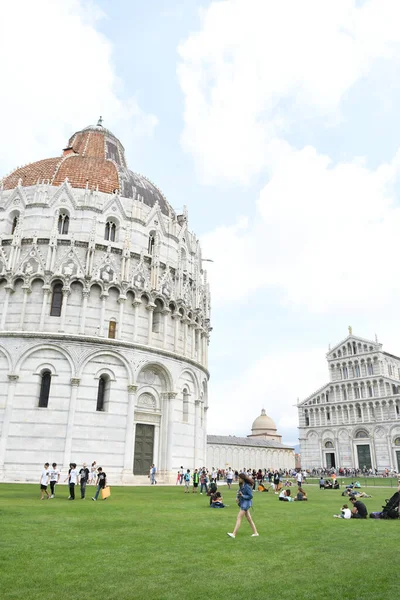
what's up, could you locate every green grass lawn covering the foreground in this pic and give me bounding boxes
[0,484,400,600]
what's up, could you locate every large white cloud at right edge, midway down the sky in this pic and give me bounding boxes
[202,143,400,313]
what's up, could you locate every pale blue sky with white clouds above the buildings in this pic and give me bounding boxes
[0,0,400,444]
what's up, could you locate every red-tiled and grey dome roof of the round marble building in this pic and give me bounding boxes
[2,117,174,215]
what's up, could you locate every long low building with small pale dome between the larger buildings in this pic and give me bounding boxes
[207,409,295,471]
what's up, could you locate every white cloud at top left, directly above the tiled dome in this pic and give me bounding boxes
[0,0,156,175]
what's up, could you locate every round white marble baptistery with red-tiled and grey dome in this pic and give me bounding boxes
[0,119,211,483]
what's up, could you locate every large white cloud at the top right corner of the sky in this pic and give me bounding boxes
[178,0,400,183]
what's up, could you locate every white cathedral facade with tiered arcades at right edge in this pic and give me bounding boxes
[298,336,400,472]
